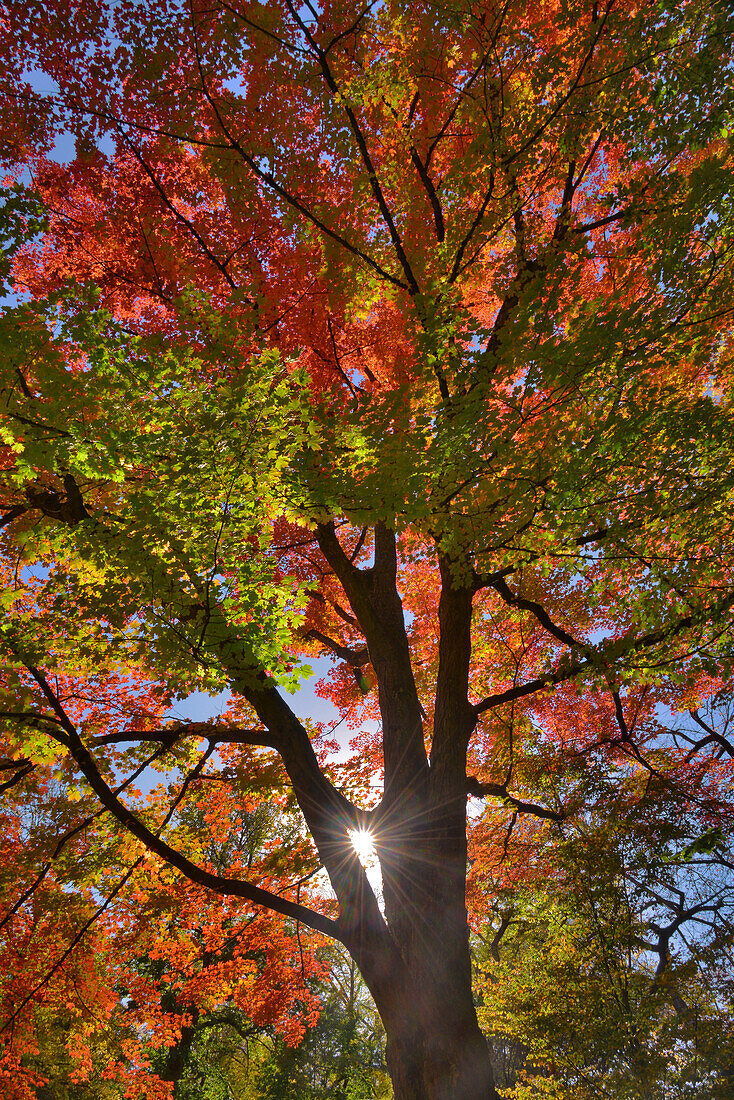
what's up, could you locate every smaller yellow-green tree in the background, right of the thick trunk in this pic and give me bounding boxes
[472,743,734,1100]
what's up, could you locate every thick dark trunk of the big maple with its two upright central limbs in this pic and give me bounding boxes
[316,524,497,1100]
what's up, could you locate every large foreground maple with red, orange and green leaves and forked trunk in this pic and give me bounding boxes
[1,0,734,1100]
